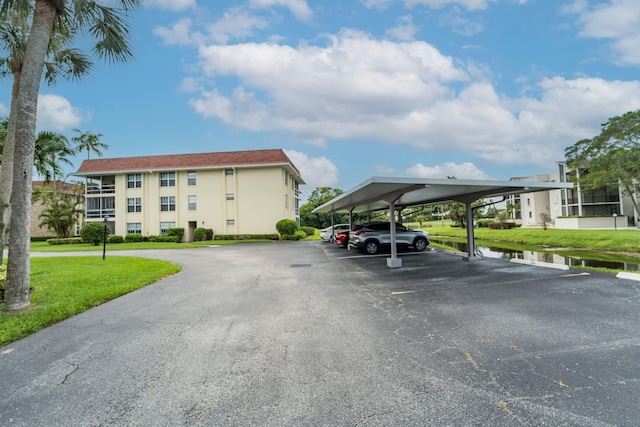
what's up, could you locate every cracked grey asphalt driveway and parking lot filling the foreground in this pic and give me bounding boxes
[0,242,640,426]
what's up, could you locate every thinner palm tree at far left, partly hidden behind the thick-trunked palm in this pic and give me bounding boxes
[0,3,92,259]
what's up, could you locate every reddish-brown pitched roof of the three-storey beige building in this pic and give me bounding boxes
[74,148,300,177]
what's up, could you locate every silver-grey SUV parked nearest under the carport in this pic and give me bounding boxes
[349,221,431,255]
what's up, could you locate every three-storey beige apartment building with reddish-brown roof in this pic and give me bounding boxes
[74,149,304,241]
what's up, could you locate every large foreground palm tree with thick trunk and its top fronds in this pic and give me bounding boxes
[0,0,142,310]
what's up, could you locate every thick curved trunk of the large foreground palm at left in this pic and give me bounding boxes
[5,0,59,310]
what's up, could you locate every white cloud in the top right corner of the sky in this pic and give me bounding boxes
[563,0,640,65]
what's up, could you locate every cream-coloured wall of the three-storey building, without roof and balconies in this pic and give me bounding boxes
[96,166,298,241]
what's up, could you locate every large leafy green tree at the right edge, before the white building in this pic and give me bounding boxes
[565,110,640,219]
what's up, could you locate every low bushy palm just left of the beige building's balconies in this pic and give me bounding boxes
[33,181,84,238]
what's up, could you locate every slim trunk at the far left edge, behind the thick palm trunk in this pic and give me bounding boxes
[0,70,21,262]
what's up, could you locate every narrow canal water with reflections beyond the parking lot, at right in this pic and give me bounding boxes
[432,239,640,271]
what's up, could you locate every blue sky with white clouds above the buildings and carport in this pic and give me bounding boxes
[0,0,640,199]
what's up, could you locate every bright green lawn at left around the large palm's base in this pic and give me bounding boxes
[0,258,181,346]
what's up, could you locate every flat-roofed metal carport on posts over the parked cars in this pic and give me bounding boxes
[313,177,573,268]
